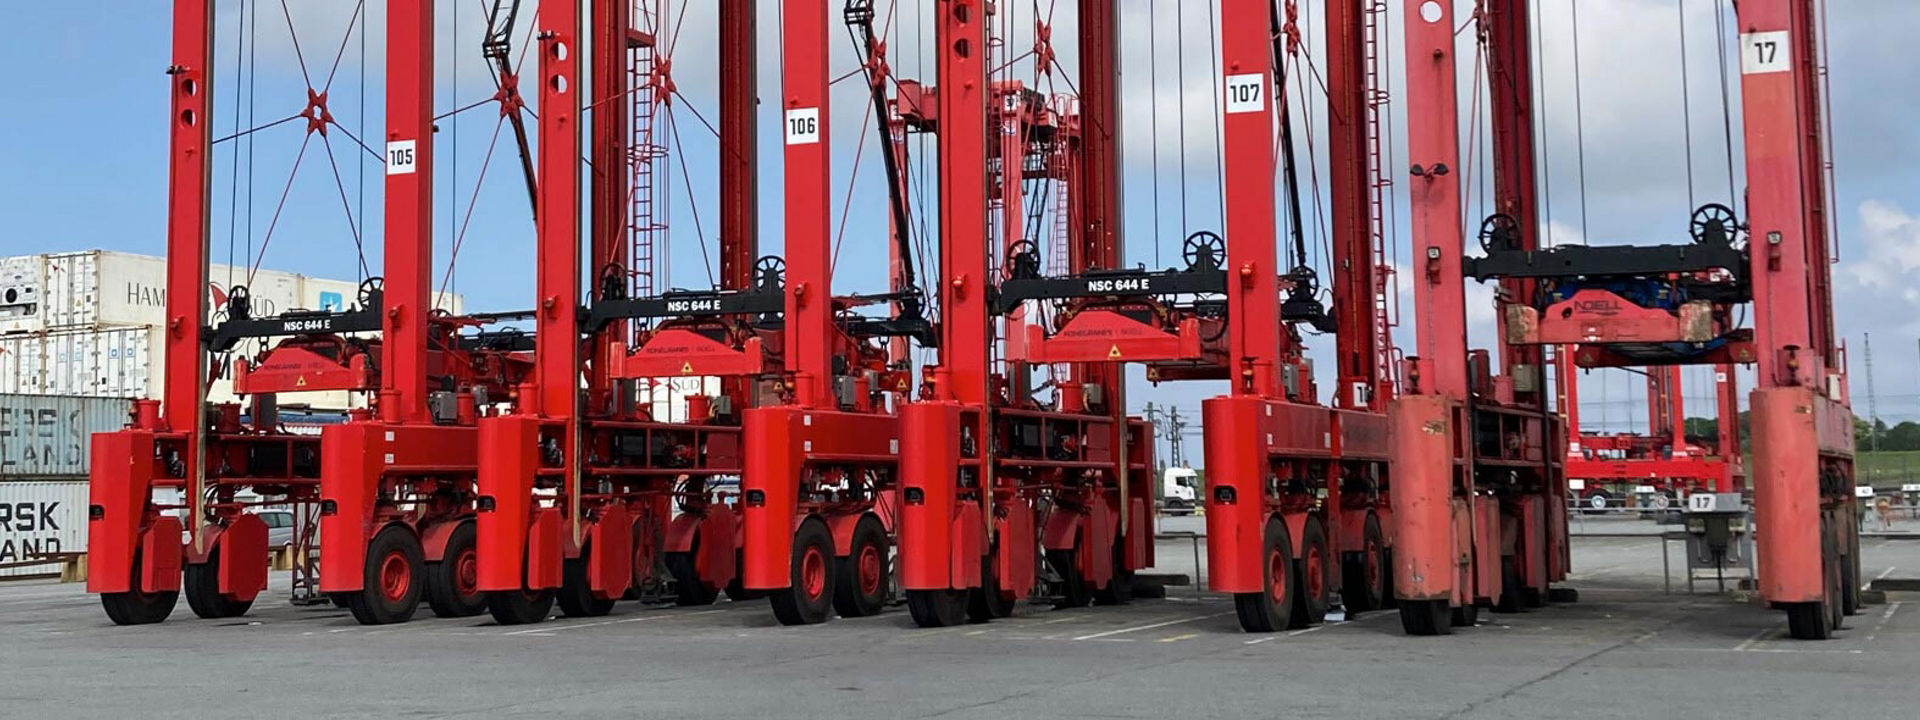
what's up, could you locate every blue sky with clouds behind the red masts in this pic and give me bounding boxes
[0,0,1920,462]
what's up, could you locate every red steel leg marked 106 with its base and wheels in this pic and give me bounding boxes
[741,0,904,624]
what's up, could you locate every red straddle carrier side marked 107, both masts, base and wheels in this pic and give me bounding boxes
[1202,0,1394,632]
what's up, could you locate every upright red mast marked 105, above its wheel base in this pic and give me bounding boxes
[380,0,434,422]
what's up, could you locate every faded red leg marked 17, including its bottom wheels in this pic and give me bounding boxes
[1738,0,1860,639]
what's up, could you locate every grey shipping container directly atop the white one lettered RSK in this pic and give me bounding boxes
[0,396,132,484]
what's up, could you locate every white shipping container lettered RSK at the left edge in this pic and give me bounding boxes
[0,478,86,578]
